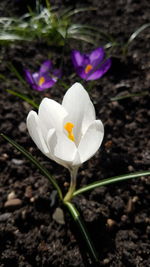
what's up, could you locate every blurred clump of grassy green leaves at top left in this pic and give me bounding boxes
[0,6,108,46]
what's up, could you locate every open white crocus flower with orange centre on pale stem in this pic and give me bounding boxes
[27,83,104,202]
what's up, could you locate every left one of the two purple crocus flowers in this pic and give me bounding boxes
[25,60,61,91]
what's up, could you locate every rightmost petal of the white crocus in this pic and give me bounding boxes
[78,120,104,163]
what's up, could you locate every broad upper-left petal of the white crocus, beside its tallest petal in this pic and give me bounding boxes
[38,98,67,133]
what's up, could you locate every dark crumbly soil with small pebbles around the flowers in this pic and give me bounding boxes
[0,0,150,267]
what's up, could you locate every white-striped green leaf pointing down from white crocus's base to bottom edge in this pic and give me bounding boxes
[64,202,100,267]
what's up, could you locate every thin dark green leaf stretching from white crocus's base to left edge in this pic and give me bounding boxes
[0,133,62,200]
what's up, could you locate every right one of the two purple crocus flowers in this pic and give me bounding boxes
[71,47,111,81]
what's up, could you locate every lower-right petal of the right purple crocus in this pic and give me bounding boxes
[86,58,111,81]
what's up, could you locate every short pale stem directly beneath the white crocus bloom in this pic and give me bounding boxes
[64,167,78,202]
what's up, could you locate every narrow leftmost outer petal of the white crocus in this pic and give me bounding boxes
[27,111,49,155]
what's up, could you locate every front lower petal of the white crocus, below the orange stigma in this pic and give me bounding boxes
[47,132,77,167]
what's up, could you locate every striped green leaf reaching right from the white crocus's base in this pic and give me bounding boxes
[73,171,150,197]
